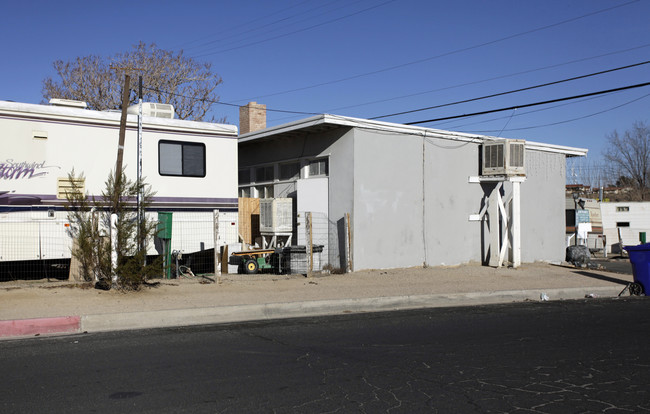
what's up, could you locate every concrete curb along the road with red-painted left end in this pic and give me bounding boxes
[0,286,623,339]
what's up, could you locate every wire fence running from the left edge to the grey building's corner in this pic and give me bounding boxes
[0,204,351,281]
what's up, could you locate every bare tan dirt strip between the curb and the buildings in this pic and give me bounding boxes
[0,263,632,320]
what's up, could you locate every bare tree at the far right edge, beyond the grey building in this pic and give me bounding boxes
[603,122,650,200]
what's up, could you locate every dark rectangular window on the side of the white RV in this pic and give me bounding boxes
[158,141,205,177]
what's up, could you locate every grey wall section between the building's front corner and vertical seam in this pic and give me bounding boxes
[352,129,424,270]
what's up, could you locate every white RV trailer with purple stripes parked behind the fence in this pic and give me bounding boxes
[0,101,238,262]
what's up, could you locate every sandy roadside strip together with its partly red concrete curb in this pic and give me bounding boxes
[0,263,633,338]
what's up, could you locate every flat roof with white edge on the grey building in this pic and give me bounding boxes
[239,114,589,157]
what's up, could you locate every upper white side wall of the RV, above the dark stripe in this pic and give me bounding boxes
[0,102,237,207]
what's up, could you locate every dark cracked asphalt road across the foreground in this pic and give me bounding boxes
[0,297,650,413]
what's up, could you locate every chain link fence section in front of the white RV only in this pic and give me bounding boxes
[0,209,239,281]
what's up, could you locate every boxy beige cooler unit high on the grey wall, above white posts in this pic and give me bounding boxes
[481,139,526,176]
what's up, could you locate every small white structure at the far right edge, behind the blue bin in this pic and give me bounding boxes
[600,201,650,252]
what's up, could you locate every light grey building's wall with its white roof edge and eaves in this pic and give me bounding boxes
[240,115,586,270]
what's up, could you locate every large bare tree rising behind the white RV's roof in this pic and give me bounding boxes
[43,42,223,121]
